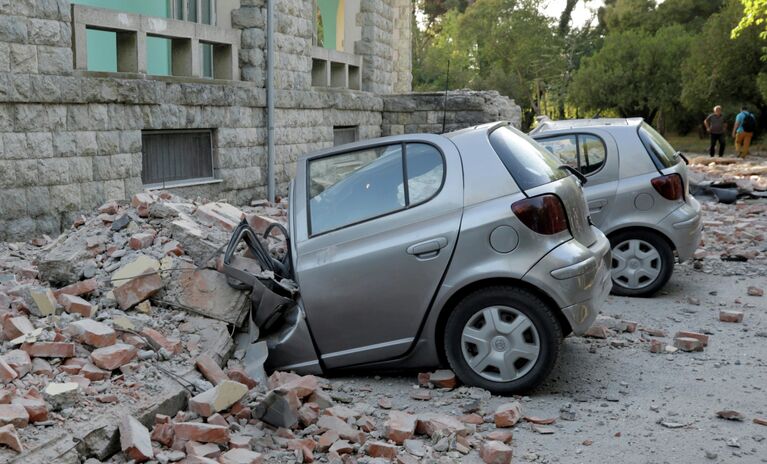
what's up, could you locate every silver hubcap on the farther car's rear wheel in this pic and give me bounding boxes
[612,239,662,289]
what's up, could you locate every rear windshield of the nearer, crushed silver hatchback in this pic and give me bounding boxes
[490,126,568,190]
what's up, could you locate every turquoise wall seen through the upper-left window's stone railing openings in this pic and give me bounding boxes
[72,0,171,76]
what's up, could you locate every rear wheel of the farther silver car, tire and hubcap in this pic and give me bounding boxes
[610,230,674,297]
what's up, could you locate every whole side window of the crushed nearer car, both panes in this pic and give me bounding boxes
[307,143,445,235]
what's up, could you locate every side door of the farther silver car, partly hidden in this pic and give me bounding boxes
[536,130,620,228]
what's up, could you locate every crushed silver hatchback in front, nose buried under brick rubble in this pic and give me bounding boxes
[225,123,611,394]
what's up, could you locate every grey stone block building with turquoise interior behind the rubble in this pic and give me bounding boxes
[0,0,519,239]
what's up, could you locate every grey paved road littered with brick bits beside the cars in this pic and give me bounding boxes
[332,265,767,464]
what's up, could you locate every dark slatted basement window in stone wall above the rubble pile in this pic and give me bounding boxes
[141,130,214,188]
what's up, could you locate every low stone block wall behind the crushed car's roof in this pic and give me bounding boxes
[381,90,522,135]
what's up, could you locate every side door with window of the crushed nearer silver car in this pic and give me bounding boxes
[291,135,463,368]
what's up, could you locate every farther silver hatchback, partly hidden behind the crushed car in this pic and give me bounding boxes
[531,118,702,296]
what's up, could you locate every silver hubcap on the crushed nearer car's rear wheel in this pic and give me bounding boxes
[461,306,541,382]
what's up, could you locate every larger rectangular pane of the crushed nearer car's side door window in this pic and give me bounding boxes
[308,144,406,235]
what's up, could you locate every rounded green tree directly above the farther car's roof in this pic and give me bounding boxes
[570,25,692,121]
